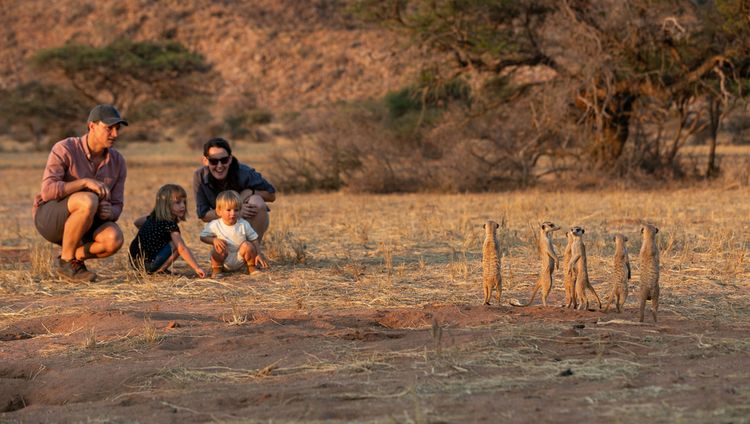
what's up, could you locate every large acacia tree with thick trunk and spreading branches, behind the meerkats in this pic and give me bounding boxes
[357,0,750,176]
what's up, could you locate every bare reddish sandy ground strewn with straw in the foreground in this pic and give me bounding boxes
[0,296,750,423]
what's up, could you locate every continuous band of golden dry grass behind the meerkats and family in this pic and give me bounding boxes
[0,176,750,319]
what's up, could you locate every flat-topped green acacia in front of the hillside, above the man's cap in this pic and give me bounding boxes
[32,40,213,121]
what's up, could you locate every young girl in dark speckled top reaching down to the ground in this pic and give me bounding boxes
[130,184,206,278]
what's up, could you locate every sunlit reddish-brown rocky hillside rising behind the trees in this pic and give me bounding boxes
[0,0,432,112]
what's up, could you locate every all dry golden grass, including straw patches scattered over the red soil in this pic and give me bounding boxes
[0,141,750,422]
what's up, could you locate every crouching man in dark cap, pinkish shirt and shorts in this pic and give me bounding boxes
[33,105,128,281]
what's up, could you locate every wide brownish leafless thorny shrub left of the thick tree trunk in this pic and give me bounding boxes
[274,81,580,193]
